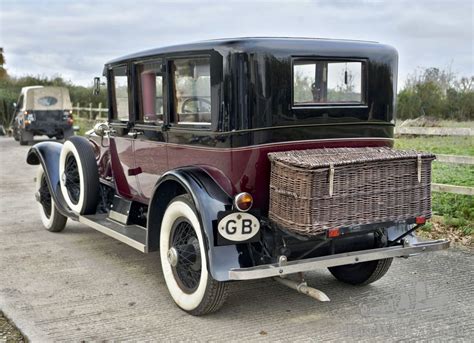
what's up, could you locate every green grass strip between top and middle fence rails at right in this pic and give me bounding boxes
[395,136,474,156]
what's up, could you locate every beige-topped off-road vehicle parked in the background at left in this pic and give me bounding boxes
[12,86,74,145]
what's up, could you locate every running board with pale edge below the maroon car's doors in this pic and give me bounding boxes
[79,213,148,252]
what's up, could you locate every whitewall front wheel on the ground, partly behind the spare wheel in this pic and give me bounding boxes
[36,165,67,232]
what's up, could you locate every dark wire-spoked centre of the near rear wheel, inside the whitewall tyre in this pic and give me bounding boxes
[168,217,201,294]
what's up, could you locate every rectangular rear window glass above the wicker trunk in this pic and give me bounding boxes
[293,60,366,106]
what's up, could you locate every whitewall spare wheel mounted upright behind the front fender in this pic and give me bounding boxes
[59,137,99,214]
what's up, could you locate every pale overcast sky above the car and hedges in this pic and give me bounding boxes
[0,0,474,89]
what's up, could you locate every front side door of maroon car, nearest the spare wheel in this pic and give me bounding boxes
[108,65,140,199]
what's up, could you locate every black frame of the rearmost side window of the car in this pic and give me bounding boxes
[166,53,212,131]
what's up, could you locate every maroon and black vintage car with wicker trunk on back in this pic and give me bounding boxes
[27,38,449,315]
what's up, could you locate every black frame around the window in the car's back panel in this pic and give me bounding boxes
[291,56,369,110]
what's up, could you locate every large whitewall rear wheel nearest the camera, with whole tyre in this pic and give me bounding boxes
[160,195,228,316]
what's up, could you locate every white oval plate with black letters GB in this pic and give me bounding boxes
[217,212,260,242]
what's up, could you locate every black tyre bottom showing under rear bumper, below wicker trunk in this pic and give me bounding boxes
[328,258,393,285]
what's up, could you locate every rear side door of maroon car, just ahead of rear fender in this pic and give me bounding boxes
[132,59,168,202]
